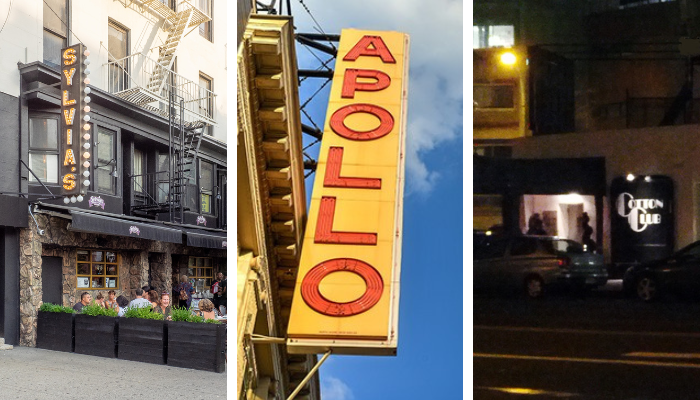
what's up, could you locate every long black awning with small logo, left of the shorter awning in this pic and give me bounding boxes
[70,211,182,244]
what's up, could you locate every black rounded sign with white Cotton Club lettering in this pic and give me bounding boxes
[610,175,674,264]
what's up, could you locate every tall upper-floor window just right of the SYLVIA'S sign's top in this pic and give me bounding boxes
[107,21,129,93]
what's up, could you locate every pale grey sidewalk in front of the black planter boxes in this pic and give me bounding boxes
[0,346,227,400]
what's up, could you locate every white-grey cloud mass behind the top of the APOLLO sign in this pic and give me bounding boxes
[293,0,463,193]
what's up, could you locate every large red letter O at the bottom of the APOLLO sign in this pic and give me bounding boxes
[301,258,384,317]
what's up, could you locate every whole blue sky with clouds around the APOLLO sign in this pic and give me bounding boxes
[292,0,463,400]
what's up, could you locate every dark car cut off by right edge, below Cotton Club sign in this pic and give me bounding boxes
[622,241,700,301]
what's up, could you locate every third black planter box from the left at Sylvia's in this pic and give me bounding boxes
[118,318,168,364]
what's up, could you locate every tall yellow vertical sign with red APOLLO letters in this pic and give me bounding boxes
[287,30,408,355]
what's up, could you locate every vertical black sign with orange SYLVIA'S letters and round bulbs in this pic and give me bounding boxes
[59,44,90,204]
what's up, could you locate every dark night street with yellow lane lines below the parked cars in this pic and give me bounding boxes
[473,285,700,400]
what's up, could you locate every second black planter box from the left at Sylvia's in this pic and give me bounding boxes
[75,314,119,358]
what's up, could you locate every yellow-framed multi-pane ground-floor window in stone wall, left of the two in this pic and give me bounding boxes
[76,250,119,289]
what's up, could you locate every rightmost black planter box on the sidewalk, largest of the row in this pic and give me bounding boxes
[167,321,226,372]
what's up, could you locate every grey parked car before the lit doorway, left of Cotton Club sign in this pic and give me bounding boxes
[474,236,608,298]
